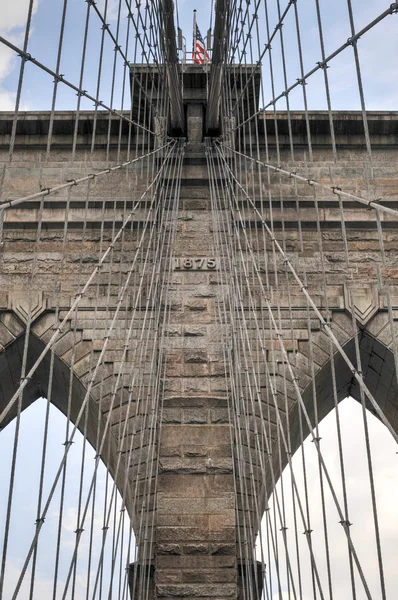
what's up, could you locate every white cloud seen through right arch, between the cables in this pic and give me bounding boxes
[257,399,398,600]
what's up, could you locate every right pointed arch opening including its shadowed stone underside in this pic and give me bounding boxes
[256,331,398,600]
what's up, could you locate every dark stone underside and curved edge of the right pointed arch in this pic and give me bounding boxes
[249,312,398,533]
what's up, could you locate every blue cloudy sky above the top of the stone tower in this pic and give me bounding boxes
[0,0,398,110]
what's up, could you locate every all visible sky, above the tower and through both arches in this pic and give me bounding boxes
[0,0,398,600]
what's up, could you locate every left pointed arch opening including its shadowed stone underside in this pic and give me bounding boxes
[0,334,145,600]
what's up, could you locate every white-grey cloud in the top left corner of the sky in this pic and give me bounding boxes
[0,0,38,110]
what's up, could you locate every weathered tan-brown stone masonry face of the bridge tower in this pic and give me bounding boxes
[0,105,398,600]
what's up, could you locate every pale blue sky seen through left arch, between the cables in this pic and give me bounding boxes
[0,398,135,600]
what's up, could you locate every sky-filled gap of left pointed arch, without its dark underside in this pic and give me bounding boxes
[0,397,135,600]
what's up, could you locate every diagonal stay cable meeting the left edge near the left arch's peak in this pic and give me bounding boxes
[0,142,176,427]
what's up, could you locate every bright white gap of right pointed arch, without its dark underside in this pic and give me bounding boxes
[256,397,398,600]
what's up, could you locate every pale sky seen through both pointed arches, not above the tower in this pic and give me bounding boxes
[0,398,398,600]
